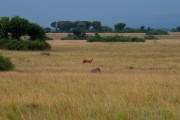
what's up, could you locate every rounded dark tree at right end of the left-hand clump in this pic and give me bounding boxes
[28,23,45,40]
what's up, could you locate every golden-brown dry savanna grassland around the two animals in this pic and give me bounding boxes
[0,33,180,120]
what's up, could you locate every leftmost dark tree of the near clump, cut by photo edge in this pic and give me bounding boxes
[0,17,10,38]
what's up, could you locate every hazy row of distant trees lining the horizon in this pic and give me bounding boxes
[46,21,151,33]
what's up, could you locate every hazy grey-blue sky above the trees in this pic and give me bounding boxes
[0,0,180,28]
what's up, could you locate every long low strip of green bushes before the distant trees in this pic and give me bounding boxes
[87,34,145,42]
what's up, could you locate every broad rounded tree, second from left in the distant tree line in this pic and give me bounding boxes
[57,21,73,32]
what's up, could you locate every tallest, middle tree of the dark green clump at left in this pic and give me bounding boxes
[10,16,29,40]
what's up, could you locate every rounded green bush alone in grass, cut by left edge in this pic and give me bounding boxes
[0,55,14,71]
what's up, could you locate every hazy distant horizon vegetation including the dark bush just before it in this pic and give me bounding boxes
[45,21,172,40]
